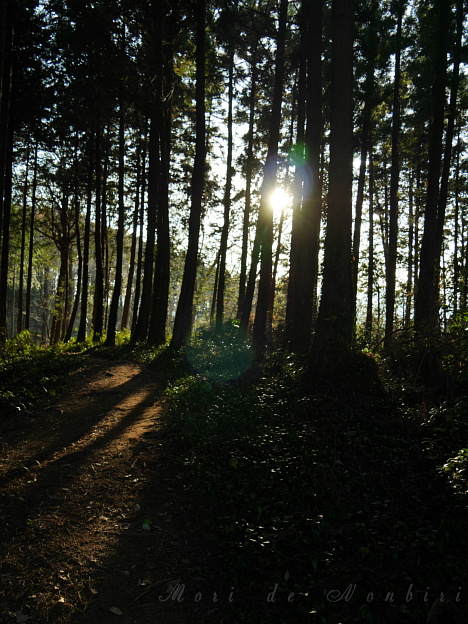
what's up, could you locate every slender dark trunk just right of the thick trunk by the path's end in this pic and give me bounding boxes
[216,47,234,331]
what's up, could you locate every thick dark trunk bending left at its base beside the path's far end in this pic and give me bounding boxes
[171,0,206,349]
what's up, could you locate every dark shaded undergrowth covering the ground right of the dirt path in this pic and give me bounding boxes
[166,348,468,624]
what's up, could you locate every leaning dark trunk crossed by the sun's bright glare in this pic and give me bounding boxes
[253,0,288,357]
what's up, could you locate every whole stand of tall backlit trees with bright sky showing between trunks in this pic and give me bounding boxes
[0,0,468,365]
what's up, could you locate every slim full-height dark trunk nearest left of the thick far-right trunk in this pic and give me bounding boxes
[385,0,404,346]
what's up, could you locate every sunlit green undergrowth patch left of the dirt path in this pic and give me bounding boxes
[0,332,87,416]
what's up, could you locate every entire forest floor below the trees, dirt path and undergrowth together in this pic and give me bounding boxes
[0,343,468,624]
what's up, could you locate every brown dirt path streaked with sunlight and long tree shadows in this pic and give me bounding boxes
[0,359,221,624]
